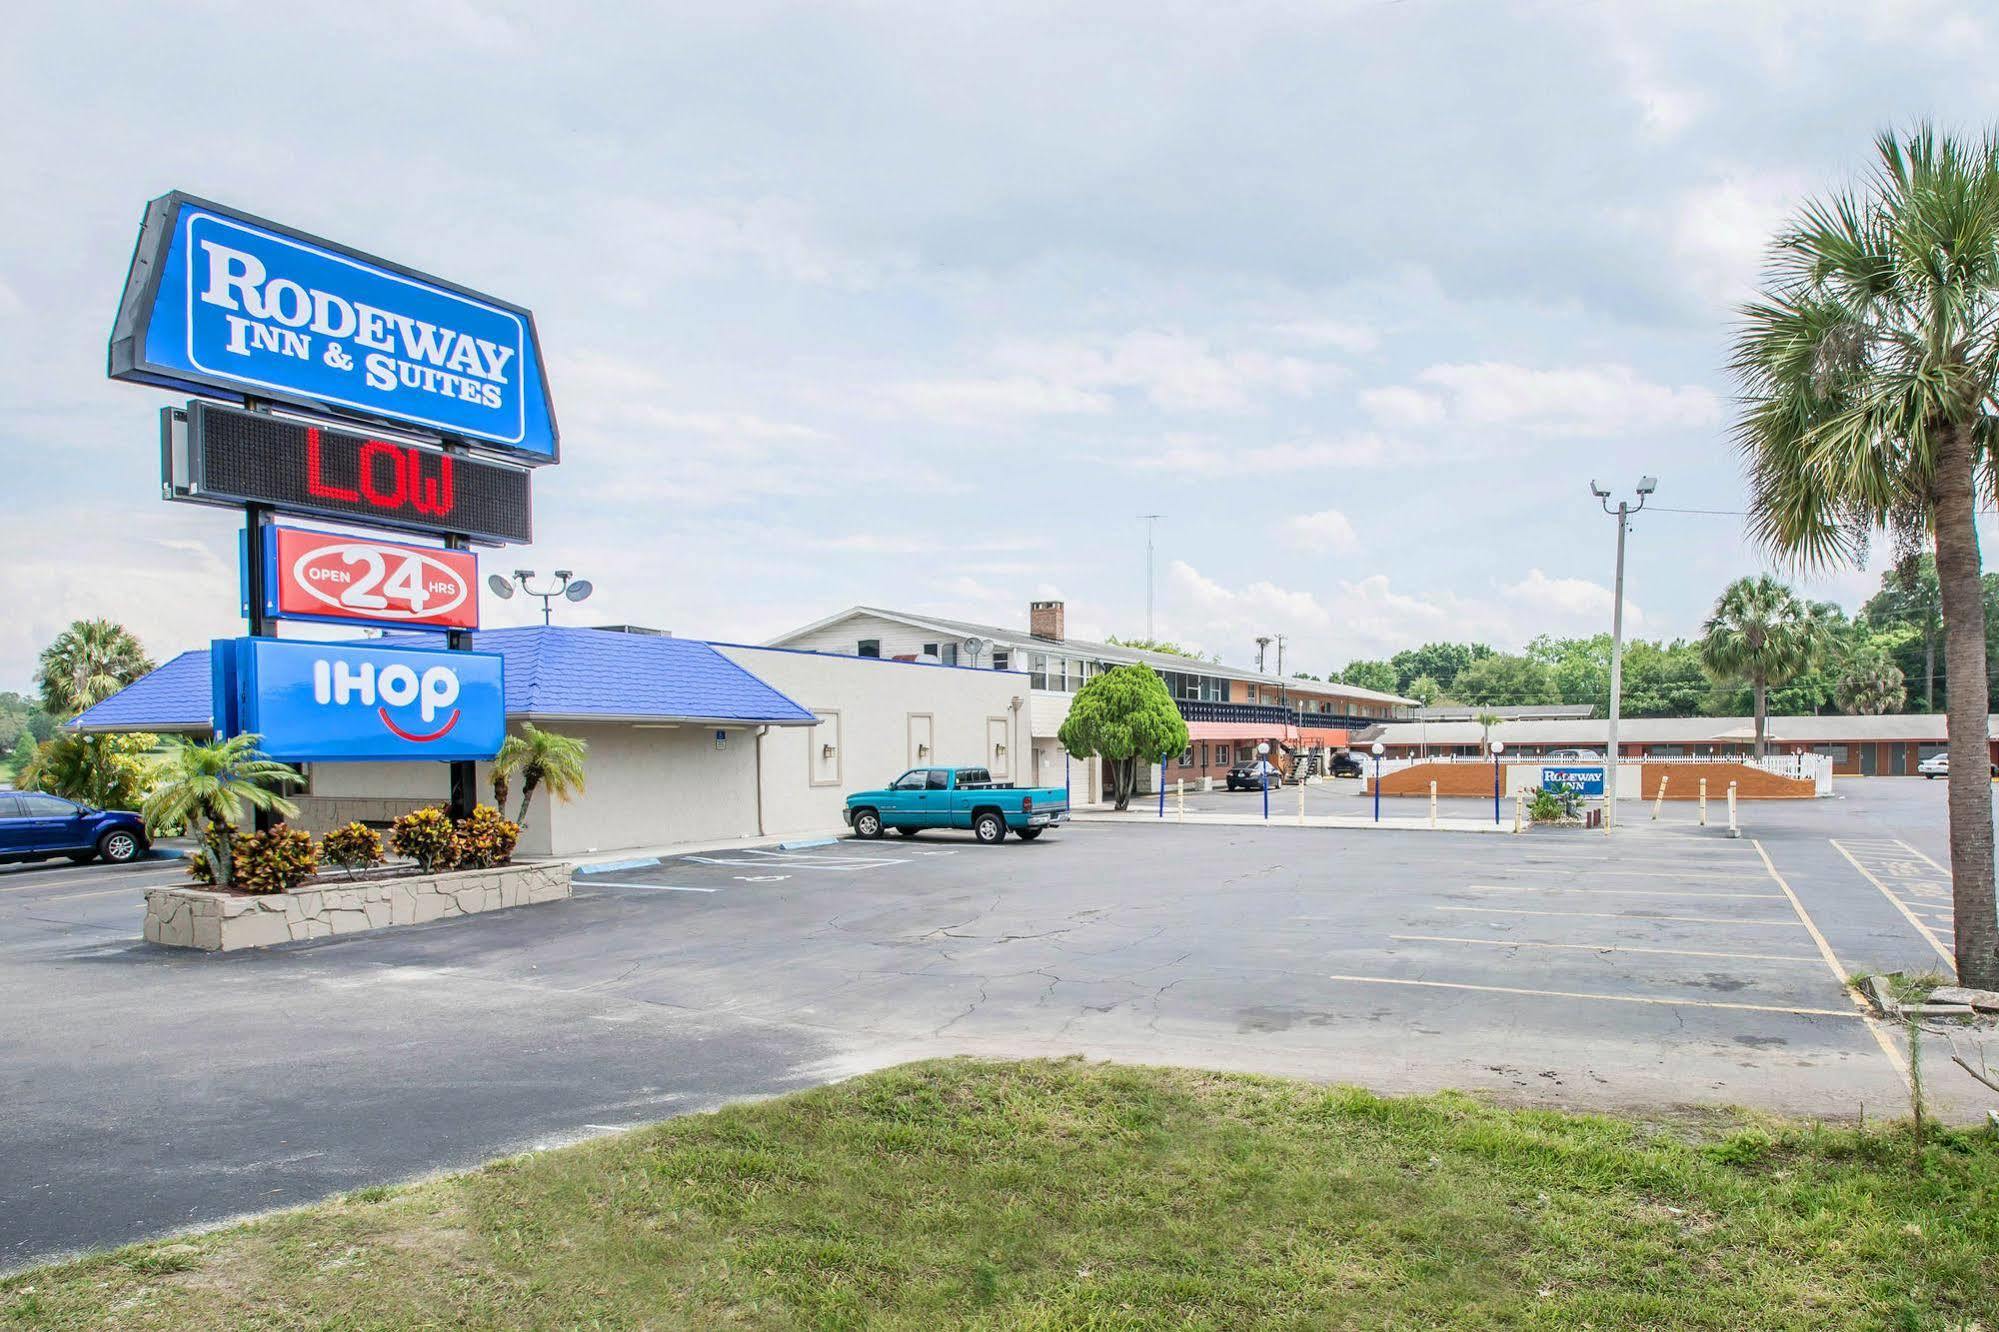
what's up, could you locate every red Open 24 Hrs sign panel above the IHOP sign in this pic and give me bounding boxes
[264,528,480,630]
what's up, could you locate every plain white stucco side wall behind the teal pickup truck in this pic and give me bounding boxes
[716,644,1031,834]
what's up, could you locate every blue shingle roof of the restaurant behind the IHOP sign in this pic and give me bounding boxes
[72,628,818,730]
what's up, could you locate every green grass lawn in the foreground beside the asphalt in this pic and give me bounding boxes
[0,1060,1999,1332]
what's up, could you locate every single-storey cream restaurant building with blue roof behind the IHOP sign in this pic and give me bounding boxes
[72,628,1031,856]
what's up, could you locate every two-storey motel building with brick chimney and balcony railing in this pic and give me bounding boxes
[770,600,1415,798]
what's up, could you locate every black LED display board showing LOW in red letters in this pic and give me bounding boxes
[166,402,534,542]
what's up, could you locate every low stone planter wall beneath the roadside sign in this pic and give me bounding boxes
[146,862,572,952]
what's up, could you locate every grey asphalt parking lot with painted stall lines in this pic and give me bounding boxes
[0,780,1973,1266]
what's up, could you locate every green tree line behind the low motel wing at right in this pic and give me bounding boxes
[1331,552,1999,716]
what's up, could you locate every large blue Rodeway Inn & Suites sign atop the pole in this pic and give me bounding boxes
[110,192,558,464]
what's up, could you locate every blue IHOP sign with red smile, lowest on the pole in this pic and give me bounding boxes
[210,638,506,762]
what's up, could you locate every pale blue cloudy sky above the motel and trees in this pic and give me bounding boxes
[0,0,1999,688]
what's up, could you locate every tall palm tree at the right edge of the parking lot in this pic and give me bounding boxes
[1733,126,1999,988]
